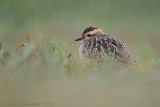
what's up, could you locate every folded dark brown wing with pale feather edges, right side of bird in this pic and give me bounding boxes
[102,34,136,63]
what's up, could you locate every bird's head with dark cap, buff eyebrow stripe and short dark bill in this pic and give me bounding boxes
[75,26,103,41]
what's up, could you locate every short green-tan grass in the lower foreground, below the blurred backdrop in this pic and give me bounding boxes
[0,32,160,107]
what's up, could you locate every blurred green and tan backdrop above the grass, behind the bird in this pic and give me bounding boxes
[0,0,160,50]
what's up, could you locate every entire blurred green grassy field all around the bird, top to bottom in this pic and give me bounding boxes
[0,0,160,107]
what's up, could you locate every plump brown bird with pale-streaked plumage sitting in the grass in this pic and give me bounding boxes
[75,26,135,64]
